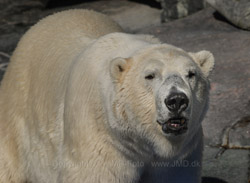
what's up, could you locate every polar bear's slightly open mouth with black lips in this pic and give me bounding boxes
[157,117,188,135]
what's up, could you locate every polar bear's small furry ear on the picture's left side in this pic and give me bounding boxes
[109,57,128,80]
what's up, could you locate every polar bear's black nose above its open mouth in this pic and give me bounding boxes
[165,92,189,113]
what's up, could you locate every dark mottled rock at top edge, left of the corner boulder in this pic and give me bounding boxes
[157,0,204,22]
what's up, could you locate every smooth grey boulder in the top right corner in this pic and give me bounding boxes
[206,0,250,30]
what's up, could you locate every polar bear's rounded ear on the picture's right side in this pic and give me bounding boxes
[189,50,214,77]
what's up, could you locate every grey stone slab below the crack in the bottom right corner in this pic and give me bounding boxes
[202,147,250,183]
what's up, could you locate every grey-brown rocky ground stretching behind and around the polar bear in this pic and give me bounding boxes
[0,0,250,183]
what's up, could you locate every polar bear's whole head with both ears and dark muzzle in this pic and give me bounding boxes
[110,44,214,156]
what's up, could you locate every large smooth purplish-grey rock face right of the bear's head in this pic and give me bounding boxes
[141,8,250,146]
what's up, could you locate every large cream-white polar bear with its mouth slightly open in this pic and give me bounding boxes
[0,10,214,183]
